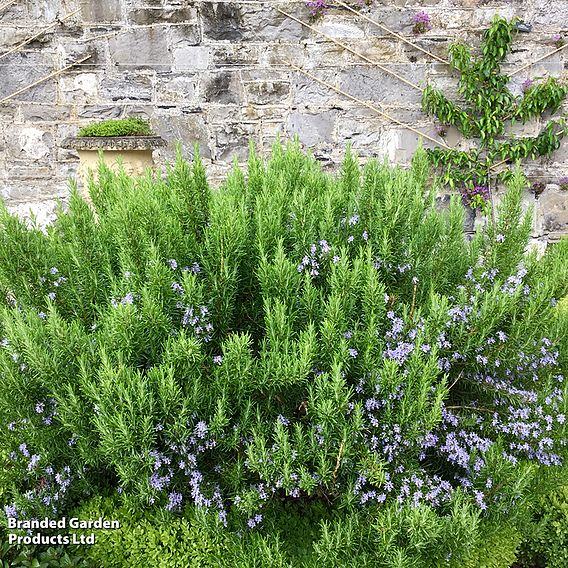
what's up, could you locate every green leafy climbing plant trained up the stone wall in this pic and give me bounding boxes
[422,16,568,203]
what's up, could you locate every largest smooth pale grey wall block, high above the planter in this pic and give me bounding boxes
[109,28,172,71]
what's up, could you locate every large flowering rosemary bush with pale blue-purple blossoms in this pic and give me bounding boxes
[0,139,568,567]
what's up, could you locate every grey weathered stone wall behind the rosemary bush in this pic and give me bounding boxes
[0,0,568,241]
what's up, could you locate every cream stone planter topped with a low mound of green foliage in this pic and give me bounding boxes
[63,117,166,194]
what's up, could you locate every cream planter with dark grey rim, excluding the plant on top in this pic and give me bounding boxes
[62,136,166,195]
